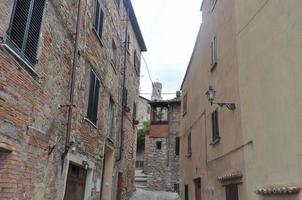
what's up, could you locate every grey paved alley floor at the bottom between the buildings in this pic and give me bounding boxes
[130,188,180,200]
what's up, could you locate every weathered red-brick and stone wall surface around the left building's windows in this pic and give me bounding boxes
[0,0,145,200]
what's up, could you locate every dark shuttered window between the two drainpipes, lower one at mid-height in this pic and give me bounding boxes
[87,70,100,124]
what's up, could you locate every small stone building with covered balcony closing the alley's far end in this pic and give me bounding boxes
[144,96,180,192]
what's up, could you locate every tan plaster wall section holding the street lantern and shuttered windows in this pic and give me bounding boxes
[181,0,248,200]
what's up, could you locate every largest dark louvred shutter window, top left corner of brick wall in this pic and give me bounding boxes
[6,0,46,66]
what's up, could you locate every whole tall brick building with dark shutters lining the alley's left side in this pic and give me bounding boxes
[0,0,146,200]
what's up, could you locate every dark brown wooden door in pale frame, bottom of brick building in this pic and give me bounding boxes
[64,164,87,200]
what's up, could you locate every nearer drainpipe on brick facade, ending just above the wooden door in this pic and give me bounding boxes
[61,0,82,172]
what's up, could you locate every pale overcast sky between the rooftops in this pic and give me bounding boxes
[132,0,202,99]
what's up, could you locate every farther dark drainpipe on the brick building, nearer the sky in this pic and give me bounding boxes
[116,1,129,162]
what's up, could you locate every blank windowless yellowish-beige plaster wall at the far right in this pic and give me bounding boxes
[236,0,302,200]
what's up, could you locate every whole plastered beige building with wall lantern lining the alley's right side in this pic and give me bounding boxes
[180,0,302,200]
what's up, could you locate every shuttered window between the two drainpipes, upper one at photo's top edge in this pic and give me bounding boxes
[93,0,104,40]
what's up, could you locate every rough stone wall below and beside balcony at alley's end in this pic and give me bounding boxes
[144,102,180,191]
